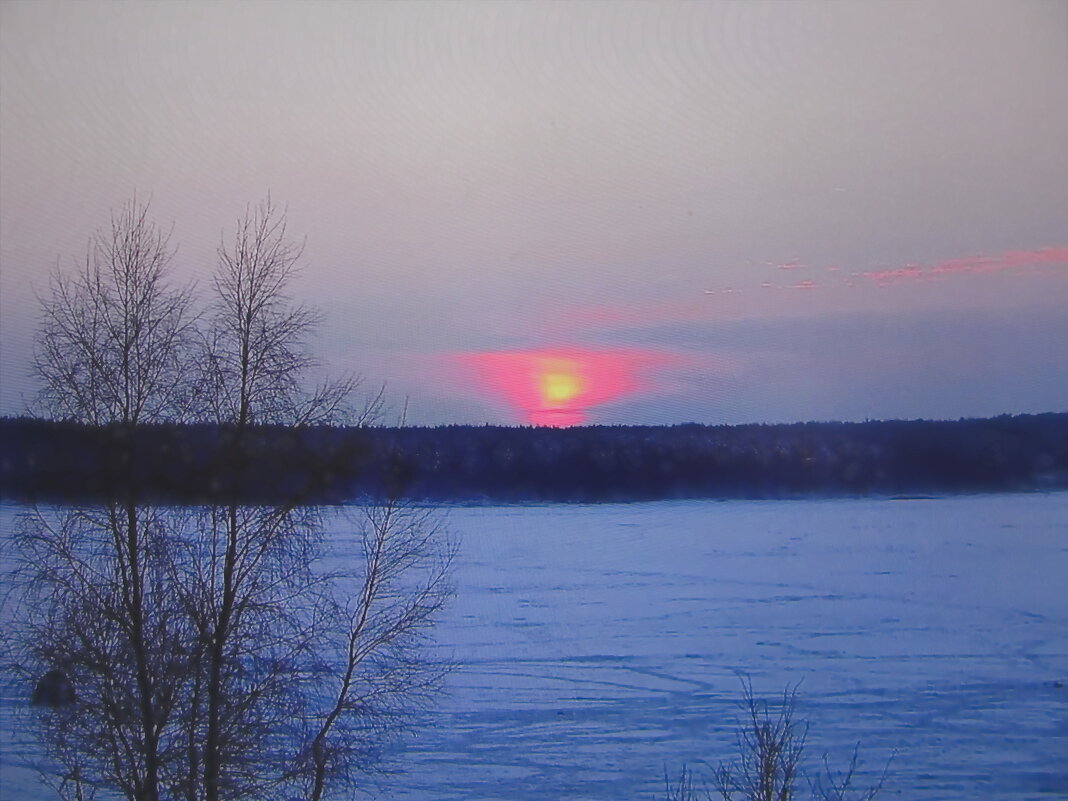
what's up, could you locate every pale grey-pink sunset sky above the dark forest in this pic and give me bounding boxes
[0,0,1068,425]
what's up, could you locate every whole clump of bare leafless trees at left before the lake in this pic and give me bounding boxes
[4,200,451,801]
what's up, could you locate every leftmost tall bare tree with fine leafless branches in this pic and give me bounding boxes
[9,200,193,800]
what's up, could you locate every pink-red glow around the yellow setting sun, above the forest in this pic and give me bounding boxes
[459,349,664,426]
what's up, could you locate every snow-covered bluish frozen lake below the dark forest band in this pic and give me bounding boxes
[0,493,1068,801]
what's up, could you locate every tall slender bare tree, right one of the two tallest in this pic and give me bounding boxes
[191,200,351,801]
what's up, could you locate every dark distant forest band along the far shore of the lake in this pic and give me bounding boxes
[0,413,1068,503]
